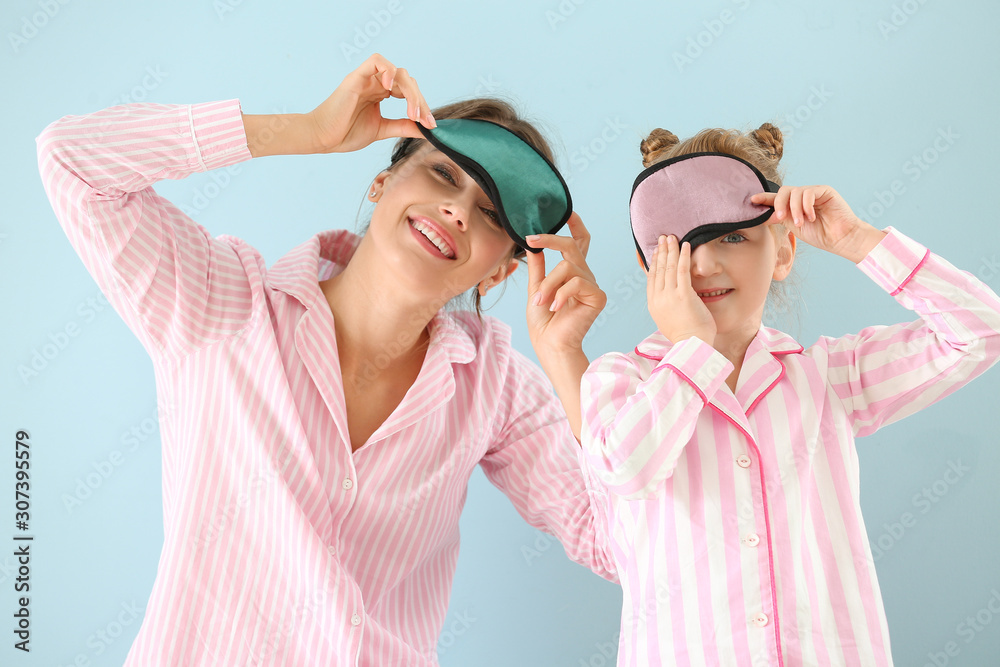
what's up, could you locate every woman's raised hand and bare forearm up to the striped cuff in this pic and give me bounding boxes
[243,53,437,157]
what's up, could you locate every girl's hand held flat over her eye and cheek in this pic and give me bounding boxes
[646,234,716,345]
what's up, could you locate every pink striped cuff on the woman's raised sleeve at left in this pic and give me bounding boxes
[188,99,252,171]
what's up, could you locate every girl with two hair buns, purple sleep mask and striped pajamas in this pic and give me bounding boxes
[582,125,1000,667]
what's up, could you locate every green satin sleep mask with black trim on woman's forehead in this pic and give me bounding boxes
[418,118,573,252]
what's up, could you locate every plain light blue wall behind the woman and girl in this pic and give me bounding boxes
[0,0,1000,667]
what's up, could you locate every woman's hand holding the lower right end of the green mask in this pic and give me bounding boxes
[526,213,608,353]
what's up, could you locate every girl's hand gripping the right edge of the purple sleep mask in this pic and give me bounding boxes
[750,185,885,263]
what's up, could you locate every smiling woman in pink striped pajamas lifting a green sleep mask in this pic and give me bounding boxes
[38,55,613,667]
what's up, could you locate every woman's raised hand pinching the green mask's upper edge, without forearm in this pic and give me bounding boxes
[306,53,437,153]
